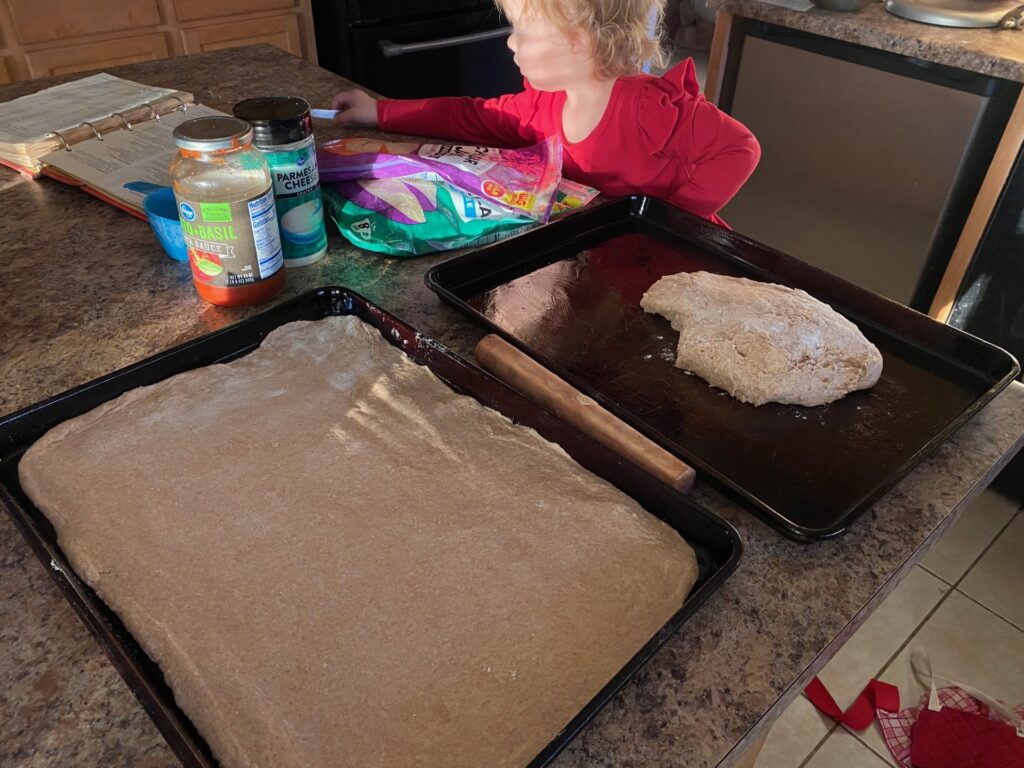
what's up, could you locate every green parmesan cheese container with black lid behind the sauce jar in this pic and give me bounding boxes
[231,96,327,268]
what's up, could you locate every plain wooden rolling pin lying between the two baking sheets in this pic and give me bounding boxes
[473,334,696,494]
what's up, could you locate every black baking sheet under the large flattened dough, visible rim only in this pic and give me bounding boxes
[0,288,741,768]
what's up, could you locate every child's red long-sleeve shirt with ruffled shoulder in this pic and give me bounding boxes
[377,58,761,223]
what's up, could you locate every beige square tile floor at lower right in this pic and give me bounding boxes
[755,487,1024,768]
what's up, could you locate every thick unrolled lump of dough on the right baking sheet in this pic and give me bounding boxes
[640,272,882,406]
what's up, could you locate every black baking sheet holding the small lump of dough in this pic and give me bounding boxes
[427,198,1019,540]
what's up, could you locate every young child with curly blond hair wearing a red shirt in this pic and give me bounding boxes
[332,0,761,224]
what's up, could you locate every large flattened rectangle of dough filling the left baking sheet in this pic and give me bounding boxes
[19,317,697,768]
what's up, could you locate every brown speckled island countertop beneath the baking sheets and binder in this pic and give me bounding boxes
[0,47,1024,768]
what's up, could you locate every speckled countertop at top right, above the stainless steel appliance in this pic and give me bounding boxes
[708,0,1024,83]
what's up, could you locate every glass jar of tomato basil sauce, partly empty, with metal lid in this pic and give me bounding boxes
[170,116,285,306]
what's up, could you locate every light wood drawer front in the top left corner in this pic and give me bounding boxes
[6,0,163,45]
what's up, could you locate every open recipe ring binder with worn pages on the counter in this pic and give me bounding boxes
[0,73,223,217]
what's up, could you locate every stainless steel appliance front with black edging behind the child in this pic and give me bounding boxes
[719,22,1020,311]
